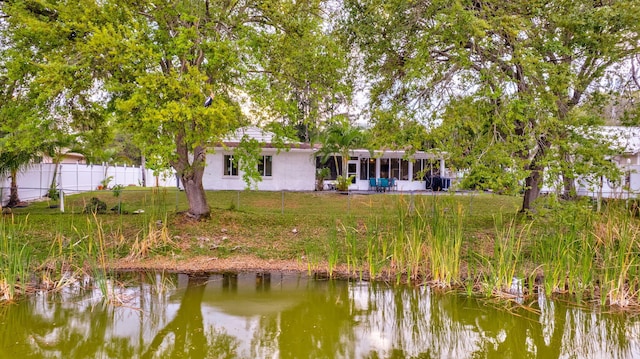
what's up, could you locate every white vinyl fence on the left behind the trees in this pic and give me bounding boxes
[0,163,177,205]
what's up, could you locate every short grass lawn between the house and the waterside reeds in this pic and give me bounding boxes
[4,187,520,260]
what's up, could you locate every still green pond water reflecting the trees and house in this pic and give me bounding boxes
[0,272,640,358]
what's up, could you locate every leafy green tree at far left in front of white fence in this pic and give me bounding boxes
[0,1,109,204]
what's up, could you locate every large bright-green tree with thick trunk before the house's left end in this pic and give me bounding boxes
[3,0,350,218]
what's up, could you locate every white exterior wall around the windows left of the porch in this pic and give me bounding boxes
[203,149,316,191]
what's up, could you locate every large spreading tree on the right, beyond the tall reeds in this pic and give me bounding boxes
[345,0,640,210]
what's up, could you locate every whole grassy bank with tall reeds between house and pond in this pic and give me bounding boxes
[0,188,640,307]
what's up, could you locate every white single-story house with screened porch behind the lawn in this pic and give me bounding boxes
[203,127,449,191]
